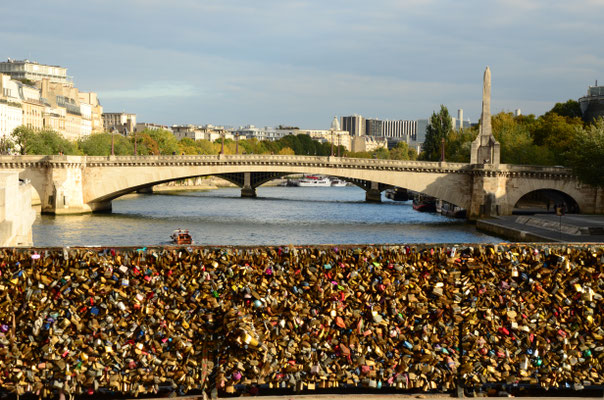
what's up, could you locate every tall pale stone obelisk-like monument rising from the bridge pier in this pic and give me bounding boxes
[470,67,500,166]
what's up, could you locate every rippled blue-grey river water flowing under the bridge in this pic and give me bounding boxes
[33,186,502,247]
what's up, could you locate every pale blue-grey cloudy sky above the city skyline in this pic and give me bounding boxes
[0,0,604,129]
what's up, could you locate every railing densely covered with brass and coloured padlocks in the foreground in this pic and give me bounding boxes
[0,244,604,397]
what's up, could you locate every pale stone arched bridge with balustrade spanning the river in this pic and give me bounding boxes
[0,155,604,218]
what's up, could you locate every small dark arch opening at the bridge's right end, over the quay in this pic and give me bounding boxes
[512,189,581,214]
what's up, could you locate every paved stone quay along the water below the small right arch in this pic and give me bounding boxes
[476,214,604,243]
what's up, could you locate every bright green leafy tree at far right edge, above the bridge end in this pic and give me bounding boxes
[566,117,604,187]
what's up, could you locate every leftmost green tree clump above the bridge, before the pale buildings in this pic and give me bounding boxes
[13,126,81,155]
